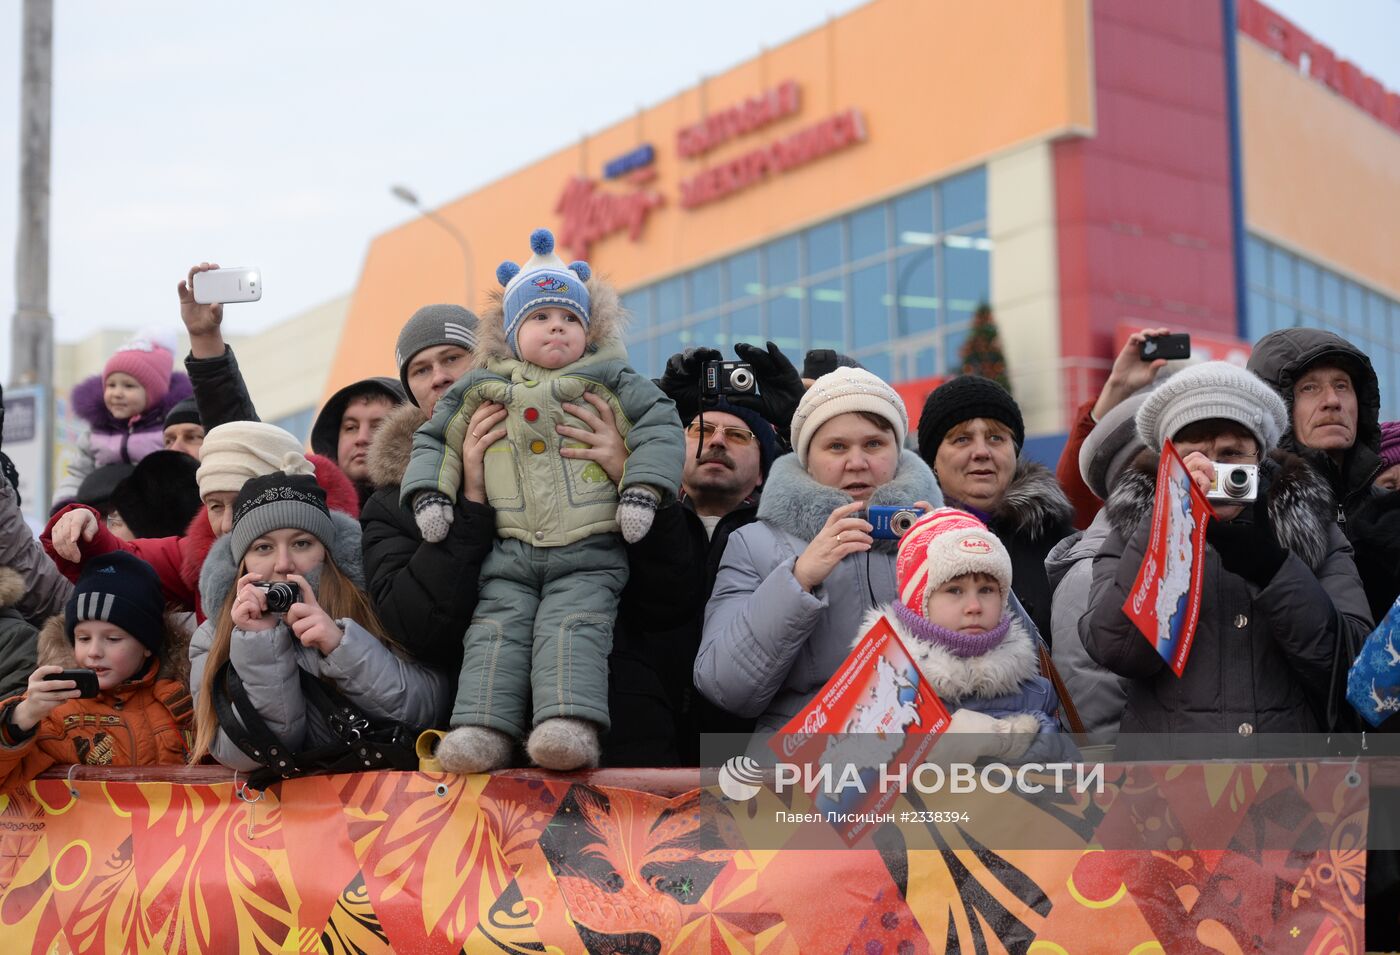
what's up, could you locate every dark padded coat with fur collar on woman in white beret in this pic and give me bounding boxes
[1079,451,1372,735]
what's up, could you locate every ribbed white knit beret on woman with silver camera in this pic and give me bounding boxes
[1137,361,1288,456]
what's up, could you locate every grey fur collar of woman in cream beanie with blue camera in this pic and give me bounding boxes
[759,451,944,550]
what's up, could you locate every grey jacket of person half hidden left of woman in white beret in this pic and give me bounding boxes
[1046,511,1130,738]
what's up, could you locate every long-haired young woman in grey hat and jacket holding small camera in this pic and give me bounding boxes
[190,465,452,770]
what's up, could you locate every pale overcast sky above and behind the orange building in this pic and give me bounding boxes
[0,0,1400,381]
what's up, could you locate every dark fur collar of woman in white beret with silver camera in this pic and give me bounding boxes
[1103,449,1336,571]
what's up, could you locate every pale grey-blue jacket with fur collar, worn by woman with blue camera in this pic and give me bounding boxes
[694,451,942,732]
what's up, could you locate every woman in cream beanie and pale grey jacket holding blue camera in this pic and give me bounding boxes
[694,368,942,731]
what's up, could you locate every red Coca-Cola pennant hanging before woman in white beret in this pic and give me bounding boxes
[1123,441,1215,676]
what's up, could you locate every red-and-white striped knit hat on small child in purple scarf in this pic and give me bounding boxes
[895,507,1011,618]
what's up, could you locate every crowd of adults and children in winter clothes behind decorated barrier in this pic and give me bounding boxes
[0,230,1400,787]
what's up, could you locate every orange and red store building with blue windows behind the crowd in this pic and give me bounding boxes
[328,0,1400,447]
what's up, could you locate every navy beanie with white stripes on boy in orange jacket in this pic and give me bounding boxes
[63,550,165,654]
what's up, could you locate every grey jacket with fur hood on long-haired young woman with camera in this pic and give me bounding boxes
[189,511,455,770]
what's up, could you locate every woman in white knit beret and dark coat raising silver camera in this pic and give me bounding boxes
[1079,361,1371,737]
